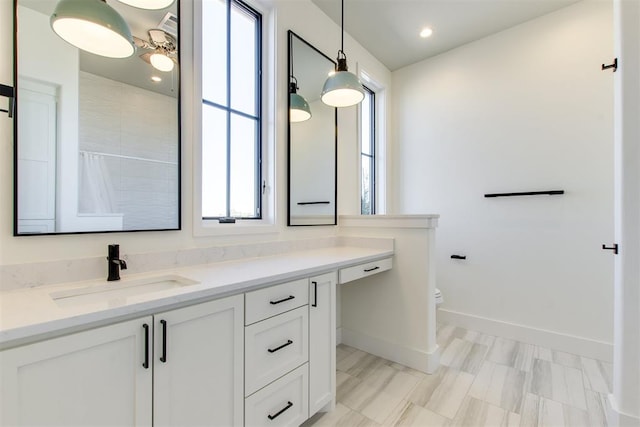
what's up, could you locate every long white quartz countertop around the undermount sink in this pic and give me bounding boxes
[0,246,393,349]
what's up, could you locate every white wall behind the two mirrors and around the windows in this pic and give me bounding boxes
[0,0,390,265]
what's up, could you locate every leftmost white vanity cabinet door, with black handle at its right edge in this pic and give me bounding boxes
[0,317,152,426]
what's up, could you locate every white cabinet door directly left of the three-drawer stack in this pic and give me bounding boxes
[153,295,244,427]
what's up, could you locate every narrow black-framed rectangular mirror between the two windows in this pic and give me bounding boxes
[287,31,338,225]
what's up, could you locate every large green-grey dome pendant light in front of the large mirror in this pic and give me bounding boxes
[50,0,135,58]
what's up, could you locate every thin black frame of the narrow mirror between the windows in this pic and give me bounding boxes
[285,30,338,227]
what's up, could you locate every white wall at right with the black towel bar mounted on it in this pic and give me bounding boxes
[392,1,613,359]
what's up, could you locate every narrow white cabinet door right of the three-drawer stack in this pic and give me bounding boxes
[309,272,336,417]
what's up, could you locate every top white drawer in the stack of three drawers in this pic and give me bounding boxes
[245,279,309,325]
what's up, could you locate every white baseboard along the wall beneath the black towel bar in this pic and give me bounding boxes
[436,308,613,362]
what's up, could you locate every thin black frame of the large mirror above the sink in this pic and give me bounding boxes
[13,0,182,237]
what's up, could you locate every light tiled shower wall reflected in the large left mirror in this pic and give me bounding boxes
[79,72,178,230]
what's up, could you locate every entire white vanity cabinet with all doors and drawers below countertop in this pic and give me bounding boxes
[0,259,392,427]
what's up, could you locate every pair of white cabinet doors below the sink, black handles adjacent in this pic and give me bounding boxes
[0,295,244,426]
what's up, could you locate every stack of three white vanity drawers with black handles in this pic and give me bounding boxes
[245,279,310,427]
